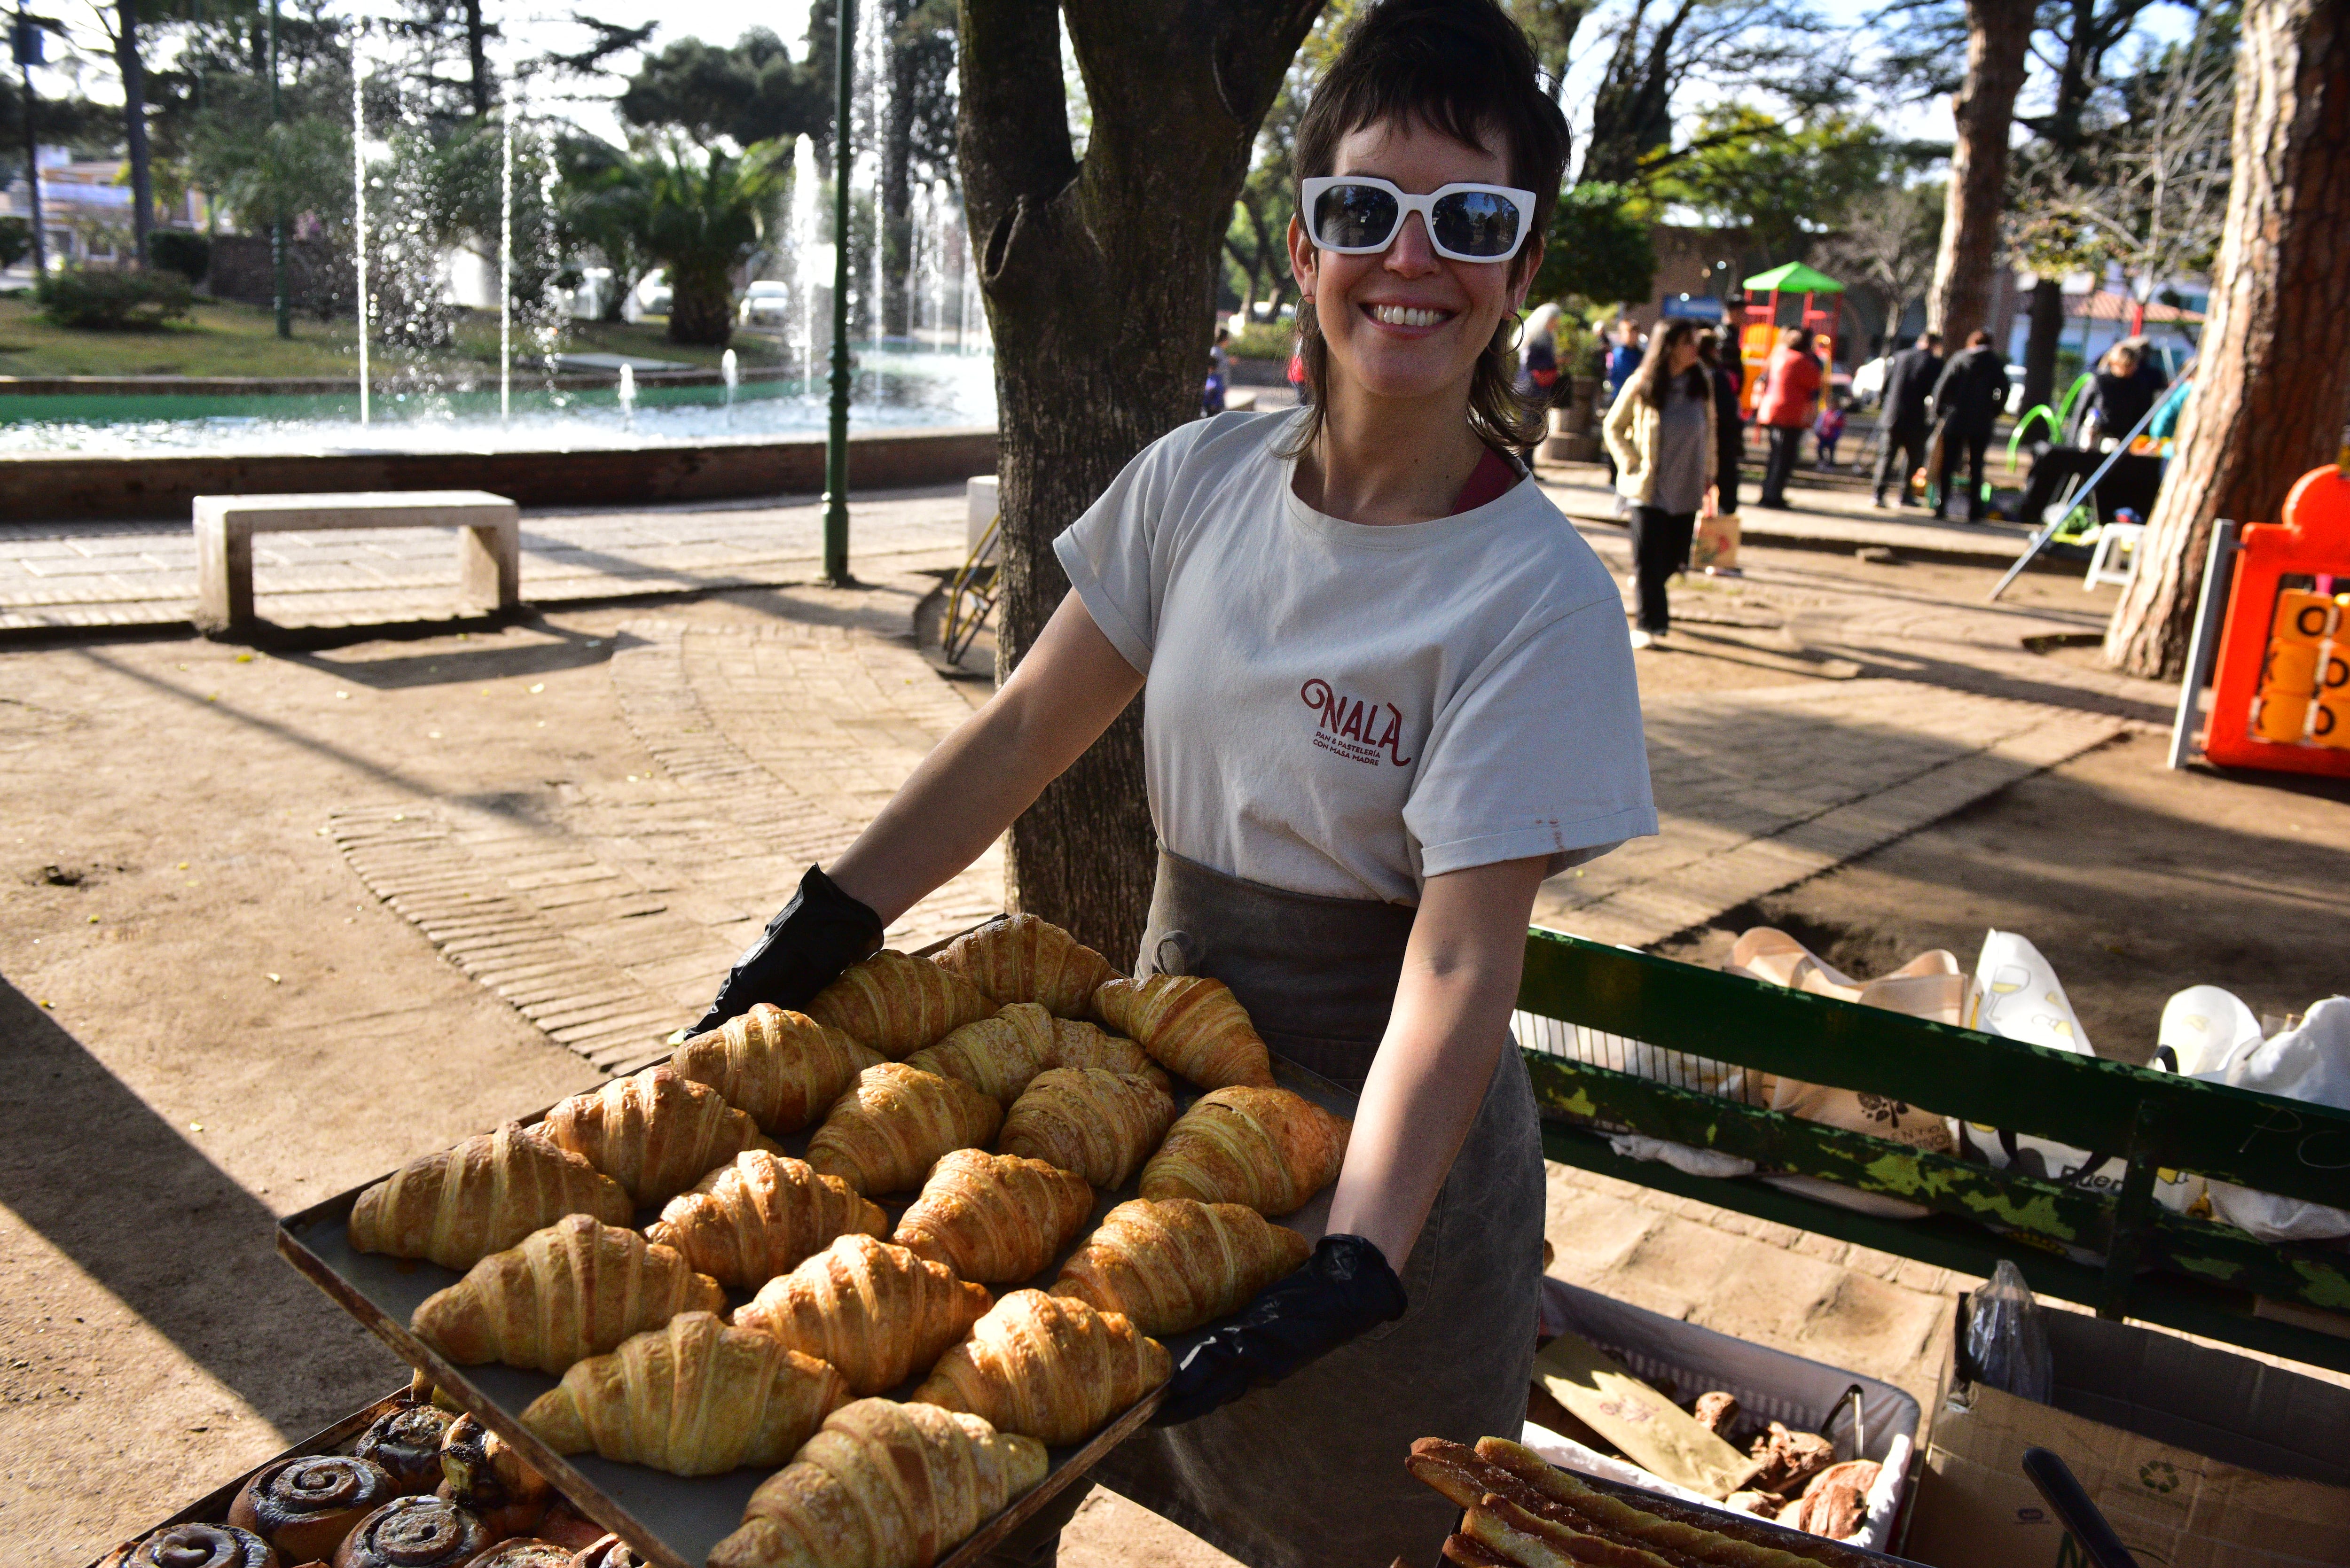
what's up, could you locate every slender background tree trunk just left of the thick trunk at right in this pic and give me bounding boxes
[1925,0,2033,341]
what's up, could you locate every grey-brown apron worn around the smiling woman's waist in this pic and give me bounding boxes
[1008,851,1544,1568]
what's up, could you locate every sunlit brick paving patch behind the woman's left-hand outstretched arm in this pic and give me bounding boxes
[331,621,1003,1072]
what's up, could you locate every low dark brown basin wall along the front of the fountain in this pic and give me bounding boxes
[0,428,996,522]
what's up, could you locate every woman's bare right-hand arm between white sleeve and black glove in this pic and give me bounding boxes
[1330,860,1542,1274]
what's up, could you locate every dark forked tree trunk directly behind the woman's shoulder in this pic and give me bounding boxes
[956,0,1321,968]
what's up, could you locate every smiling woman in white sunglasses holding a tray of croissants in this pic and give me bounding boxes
[686,0,1657,1568]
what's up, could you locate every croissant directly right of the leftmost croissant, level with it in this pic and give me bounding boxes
[644,1149,888,1291]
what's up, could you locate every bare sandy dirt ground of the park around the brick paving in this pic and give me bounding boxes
[0,533,2350,1563]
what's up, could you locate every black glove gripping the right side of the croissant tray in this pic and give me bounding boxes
[1152,1237,1408,1427]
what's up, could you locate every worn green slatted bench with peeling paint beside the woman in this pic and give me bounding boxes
[1518,931,2350,1371]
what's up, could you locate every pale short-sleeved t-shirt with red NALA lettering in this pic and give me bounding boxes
[1053,412,1657,905]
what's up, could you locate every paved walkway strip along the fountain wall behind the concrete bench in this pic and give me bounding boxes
[0,487,964,632]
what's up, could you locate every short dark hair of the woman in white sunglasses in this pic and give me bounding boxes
[1292,0,1567,452]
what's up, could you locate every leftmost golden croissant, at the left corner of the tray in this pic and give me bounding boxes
[350,1121,634,1270]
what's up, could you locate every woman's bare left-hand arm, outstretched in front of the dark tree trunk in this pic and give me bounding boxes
[827,593,1142,926]
